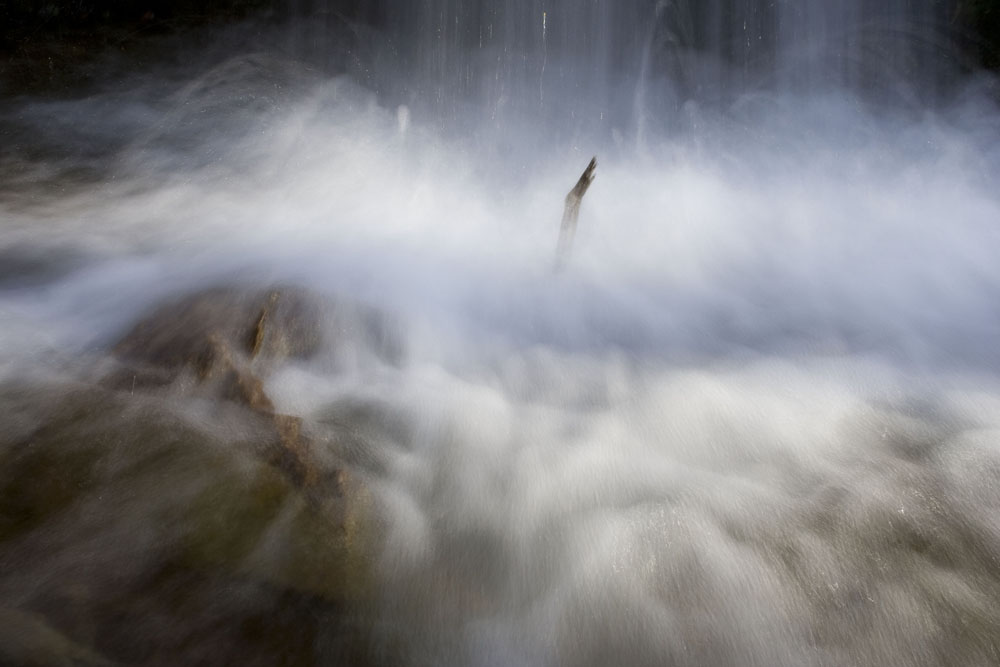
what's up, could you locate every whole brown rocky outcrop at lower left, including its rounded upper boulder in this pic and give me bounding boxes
[0,288,398,665]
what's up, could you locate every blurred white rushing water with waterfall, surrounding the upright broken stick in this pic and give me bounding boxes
[0,0,1000,665]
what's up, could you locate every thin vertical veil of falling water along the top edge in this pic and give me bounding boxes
[356,0,956,121]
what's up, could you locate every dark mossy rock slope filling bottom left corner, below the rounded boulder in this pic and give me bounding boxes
[0,385,374,664]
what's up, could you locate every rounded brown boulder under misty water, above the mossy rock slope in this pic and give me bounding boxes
[110,286,402,394]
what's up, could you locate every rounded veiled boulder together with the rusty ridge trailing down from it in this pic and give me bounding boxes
[103,287,399,493]
